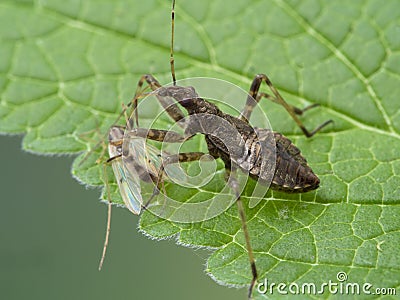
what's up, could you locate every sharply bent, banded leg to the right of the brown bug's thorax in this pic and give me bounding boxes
[239,74,333,137]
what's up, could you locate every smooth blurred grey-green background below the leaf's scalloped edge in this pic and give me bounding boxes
[0,137,242,300]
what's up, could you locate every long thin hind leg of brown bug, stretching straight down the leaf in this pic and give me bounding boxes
[225,168,258,299]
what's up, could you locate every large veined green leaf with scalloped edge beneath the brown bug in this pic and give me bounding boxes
[0,0,400,297]
